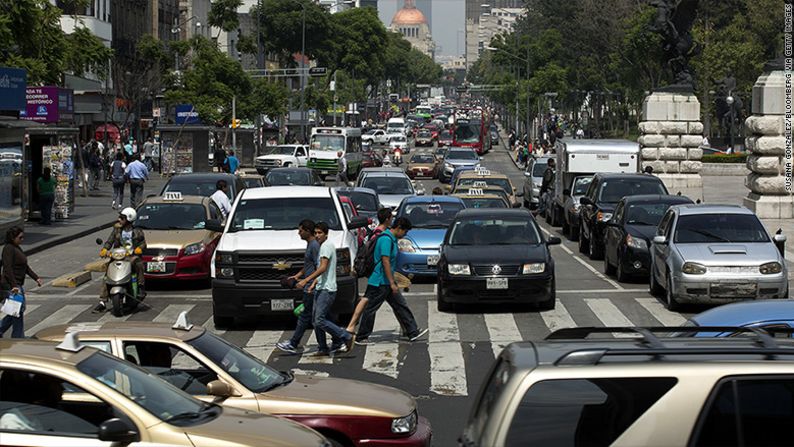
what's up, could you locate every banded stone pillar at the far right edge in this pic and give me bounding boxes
[744,65,794,219]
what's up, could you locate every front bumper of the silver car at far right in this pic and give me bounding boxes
[673,271,788,304]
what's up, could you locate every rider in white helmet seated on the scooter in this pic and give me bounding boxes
[92,208,146,313]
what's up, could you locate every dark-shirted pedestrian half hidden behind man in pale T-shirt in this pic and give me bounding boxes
[276,219,320,354]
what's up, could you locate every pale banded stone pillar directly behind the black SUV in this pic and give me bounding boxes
[639,92,703,201]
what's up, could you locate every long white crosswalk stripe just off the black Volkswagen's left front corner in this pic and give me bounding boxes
[427,302,469,396]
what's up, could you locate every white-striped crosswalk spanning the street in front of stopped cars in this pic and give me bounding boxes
[15,294,686,396]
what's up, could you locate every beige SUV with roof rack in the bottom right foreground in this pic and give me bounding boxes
[460,328,794,447]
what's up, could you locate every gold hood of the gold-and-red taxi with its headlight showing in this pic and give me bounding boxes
[260,374,416,418]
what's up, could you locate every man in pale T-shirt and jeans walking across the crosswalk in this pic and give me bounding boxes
[297,222,355,355]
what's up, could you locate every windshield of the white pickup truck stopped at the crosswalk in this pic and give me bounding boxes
[229,197,342,232]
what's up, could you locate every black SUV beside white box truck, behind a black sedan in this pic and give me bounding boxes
[579,174,668,259]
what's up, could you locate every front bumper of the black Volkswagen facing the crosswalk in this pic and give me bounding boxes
[438,273,554,304]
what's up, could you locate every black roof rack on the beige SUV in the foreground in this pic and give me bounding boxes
[546,326,794,366]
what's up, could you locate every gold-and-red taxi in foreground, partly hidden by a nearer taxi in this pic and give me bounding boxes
[35,312,431,446]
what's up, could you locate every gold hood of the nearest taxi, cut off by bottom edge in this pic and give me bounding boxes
[180,407,325,447]
